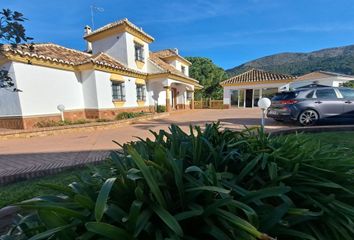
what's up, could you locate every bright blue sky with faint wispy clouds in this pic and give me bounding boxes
[0,0,354,69]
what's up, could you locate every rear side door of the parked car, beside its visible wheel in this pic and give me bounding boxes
[314,88,344,118]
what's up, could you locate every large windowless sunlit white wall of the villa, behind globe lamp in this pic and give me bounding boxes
[13,62,84,116]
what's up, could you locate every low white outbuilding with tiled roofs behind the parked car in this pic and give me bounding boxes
[220,69,354,108]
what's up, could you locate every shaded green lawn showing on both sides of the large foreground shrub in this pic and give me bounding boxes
[0,132,354,208]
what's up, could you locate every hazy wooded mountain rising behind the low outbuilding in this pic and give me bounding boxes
[226,45,354,76]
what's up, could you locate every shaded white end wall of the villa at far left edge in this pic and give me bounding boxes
[0,62,22,117]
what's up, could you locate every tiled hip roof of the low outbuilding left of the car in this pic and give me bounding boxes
[220,69,295,85]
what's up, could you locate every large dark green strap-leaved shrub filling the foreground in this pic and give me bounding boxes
[1,124,354,240]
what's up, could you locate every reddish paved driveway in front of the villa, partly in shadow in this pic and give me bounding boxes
[0,109,286,184]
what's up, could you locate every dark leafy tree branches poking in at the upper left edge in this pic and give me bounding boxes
[0,9,32,91]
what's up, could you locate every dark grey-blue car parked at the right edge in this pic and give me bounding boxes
[267,87,354,126]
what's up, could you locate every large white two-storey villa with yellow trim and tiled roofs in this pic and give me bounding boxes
[0,19,201,129]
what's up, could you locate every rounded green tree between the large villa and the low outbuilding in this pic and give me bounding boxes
[187,57,227,99]
